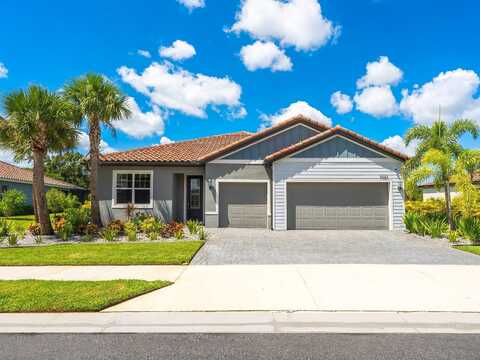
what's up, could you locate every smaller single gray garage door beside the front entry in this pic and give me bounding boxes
[219,183,267,228]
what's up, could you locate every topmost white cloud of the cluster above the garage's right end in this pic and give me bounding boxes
[357,56,403,89]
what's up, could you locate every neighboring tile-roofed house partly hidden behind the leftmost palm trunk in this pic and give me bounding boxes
[0,161,85,206]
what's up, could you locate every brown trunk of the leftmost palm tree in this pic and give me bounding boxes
[33,150,53,235]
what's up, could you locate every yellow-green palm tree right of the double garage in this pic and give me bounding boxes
[404,119,479,229]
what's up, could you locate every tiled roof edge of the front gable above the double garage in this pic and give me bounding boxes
[265,125,409,162]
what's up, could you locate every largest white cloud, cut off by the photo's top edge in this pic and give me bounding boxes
[230,0,340,50]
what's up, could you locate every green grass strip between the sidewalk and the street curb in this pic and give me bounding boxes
[0,280,170,313]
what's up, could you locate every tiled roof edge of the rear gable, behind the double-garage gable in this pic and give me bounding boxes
[200,115,330,161]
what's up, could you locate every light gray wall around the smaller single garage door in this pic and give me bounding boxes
[205,163,271,227]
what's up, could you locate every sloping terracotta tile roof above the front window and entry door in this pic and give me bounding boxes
[101,131,251,164]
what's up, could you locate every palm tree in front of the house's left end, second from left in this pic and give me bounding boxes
[64,74,130,225]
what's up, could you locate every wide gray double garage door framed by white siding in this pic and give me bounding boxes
[287,183,389,230]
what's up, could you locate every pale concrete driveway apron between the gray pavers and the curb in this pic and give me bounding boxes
[104,264,480,312]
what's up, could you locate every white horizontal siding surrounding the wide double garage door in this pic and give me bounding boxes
[273,159,405,230]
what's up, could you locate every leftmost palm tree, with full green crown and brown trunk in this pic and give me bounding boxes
[0,86,80,235]
